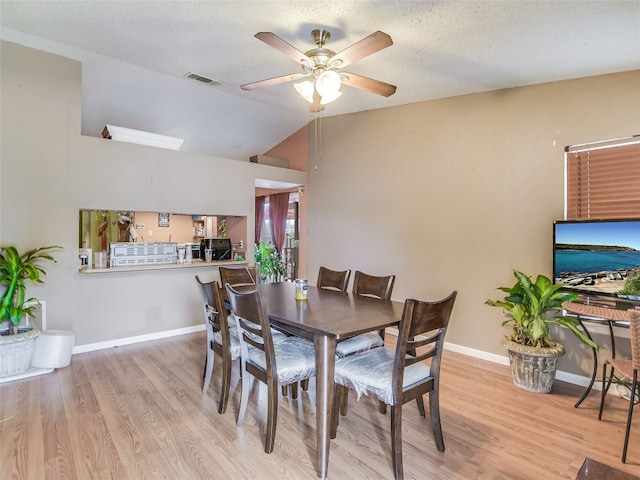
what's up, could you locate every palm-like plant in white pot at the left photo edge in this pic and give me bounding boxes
[0,246,61,377]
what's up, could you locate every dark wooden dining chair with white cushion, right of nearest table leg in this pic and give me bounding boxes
[331,291,458,480]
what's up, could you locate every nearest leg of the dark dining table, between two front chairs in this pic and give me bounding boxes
[313,335,336,478]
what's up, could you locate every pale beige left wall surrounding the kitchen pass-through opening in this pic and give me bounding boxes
[0,42,306,346]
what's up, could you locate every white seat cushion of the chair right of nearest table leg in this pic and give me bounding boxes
[335,347,431,405]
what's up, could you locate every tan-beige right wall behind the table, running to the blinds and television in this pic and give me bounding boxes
[305,71,640,373]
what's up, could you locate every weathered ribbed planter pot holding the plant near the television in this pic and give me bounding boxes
[502,338,564,393]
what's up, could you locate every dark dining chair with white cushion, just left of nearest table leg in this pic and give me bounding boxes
[227,284,316,453]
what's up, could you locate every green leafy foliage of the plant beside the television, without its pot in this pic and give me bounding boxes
[485,270,598,349]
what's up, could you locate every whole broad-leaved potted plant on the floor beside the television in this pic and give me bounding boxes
[485,270,598,393]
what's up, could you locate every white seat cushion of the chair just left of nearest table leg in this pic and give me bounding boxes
[249,336,316,385]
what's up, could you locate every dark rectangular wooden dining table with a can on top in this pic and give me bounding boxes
[238,282,404,478]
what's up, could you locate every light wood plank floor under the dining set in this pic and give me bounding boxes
[0,333,640,480]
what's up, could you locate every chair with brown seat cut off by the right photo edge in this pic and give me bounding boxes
[598,309,640,463]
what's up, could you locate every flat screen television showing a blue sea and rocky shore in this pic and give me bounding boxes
[553,219,640,301]
